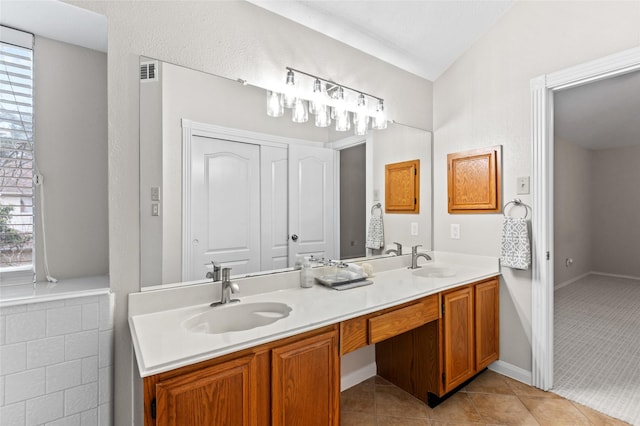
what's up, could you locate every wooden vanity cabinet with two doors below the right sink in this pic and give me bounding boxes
[376,277,499,407]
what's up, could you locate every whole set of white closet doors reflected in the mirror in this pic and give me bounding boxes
[183,135,335,281]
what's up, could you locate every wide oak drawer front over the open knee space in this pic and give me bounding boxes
[369,294,438,344]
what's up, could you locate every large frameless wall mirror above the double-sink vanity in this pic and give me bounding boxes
[140,57,432,288]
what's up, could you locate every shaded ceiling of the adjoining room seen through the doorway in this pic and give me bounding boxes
[553,71,640,149]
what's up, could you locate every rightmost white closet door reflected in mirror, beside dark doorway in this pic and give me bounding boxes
[289,145,339,265]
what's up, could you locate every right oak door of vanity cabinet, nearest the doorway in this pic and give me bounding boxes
[475,279,500,371]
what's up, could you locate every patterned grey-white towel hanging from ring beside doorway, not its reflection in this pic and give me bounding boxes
[500,216,531,269]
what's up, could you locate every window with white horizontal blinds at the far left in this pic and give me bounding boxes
[0,27,34,283]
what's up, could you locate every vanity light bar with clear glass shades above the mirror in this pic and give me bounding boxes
[267,67,387,136]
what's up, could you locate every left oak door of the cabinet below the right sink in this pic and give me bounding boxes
[442,286,475,393]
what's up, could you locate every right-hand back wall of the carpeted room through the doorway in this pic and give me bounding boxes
[591,146,640,278]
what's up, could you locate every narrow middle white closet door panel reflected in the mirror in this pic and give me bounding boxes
[260,146,289,270]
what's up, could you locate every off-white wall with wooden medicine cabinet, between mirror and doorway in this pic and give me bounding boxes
[434,1,640,371]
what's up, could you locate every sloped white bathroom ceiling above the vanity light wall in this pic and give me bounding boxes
[248,0,513,81]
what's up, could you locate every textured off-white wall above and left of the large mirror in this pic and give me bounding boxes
[67,1,432,425]
